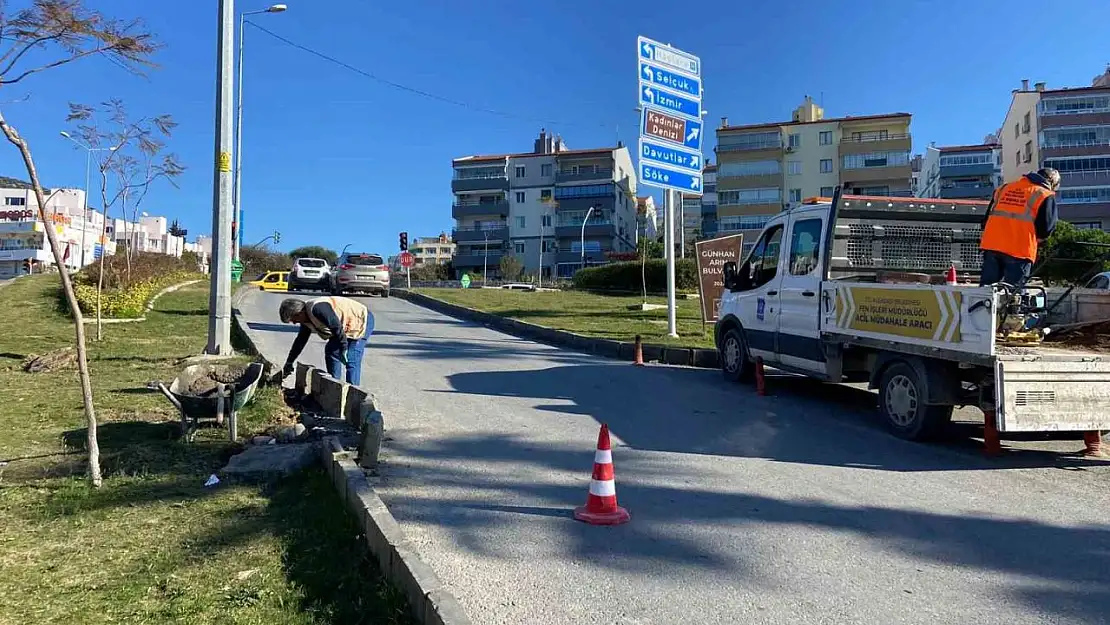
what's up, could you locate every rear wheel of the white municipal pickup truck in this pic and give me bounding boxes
[879,362,952,441]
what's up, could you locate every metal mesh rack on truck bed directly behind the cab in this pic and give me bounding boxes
[829,195,988,279]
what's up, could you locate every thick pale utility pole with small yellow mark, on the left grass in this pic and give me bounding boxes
[205,0,235,355]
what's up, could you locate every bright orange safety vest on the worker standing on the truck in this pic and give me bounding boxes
[979,178,1052,261]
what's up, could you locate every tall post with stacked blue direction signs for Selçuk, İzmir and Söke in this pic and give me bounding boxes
[636,37,701,337]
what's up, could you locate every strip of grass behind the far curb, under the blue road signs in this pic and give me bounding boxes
[415,289,714,347]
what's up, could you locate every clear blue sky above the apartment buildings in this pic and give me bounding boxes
[0,0,1110,254]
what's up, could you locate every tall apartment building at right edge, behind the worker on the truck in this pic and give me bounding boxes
[999,65,1110,230]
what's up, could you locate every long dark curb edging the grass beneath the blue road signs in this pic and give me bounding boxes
[393,289,719,369]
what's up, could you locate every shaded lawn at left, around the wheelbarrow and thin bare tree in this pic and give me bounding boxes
[0,276,412,624]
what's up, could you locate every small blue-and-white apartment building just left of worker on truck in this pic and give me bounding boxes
[915,143,1002,200]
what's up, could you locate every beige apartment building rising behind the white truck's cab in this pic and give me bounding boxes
[716,95,912,249]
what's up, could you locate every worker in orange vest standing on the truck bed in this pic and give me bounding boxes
[979,168,1060,288]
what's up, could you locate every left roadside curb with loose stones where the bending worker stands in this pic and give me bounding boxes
[231,289,472,625]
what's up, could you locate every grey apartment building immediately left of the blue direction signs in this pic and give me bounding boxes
[451,130,636,278]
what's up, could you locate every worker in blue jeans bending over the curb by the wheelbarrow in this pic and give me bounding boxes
[278,298,374,386]
